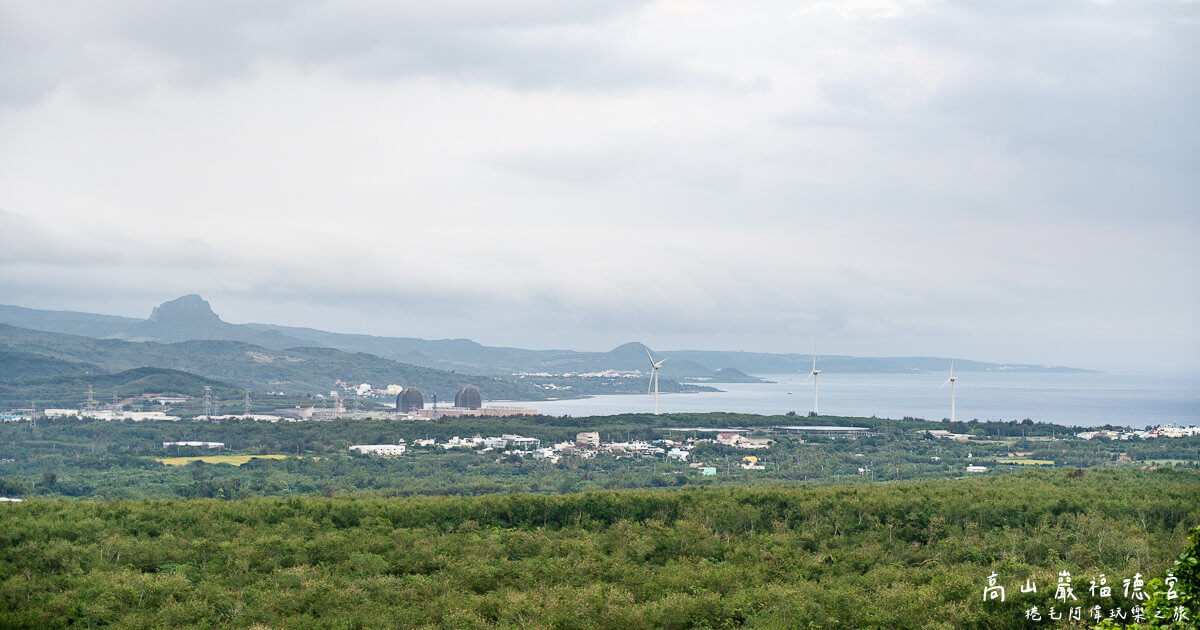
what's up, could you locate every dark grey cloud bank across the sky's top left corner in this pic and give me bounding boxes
[0,0,710,103]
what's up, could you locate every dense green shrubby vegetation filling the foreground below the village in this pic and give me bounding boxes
[0,470,1200,629]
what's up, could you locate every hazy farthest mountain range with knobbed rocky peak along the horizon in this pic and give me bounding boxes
[0,294,1088,379]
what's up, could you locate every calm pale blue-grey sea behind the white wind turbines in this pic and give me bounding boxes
[498,372,1200,428]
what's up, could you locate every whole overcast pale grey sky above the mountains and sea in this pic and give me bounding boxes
[0,0,1200,373]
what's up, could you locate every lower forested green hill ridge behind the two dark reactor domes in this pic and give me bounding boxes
[0,324,545,402]
